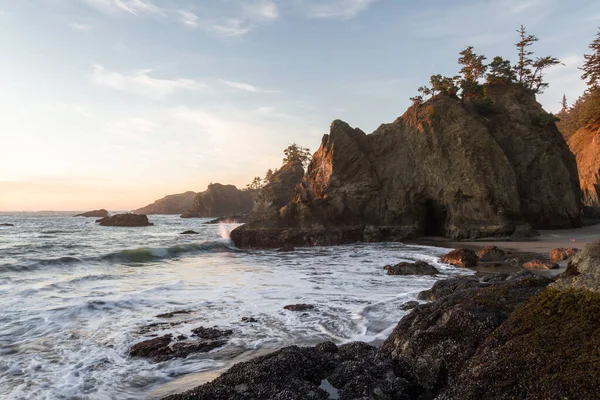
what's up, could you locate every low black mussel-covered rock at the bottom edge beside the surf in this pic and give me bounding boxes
[165,342,423,400]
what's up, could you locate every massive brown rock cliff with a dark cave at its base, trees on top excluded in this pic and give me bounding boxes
[231,86,581,247]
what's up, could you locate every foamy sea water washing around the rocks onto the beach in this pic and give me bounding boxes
[0,212,472,399]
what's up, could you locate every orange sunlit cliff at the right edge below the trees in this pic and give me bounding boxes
[569,125,600,218]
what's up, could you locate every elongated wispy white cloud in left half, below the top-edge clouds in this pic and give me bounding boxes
[93,65,206,99]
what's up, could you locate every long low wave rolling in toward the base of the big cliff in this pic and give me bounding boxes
[0,240,239,272]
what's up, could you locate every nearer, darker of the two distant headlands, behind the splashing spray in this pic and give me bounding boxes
[181,183,256,218]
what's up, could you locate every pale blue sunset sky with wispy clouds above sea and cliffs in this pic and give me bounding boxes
[0,0,600,211]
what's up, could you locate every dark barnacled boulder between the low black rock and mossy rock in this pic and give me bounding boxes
[381,270,551,393]
